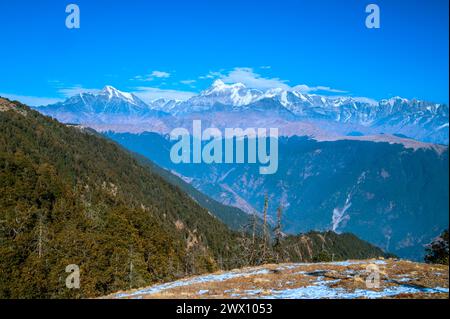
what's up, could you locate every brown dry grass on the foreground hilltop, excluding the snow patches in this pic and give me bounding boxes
[107,259,449,299]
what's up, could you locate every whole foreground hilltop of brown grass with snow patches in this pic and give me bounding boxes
[106,259,449,299]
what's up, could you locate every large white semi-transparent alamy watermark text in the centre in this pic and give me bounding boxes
[170,120,278,175]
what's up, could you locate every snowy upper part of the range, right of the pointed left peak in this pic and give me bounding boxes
[151,80,448,135]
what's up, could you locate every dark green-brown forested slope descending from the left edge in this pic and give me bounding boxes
[0,100,243,298]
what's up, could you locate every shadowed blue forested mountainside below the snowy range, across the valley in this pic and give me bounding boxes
[103,132,449,260]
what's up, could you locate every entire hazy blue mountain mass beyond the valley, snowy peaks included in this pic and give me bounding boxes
[29,84,449,259]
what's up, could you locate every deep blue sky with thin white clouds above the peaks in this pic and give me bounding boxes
[0,0,449,105]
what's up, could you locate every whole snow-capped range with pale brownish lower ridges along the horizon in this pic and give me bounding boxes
[37,80,449,144]
